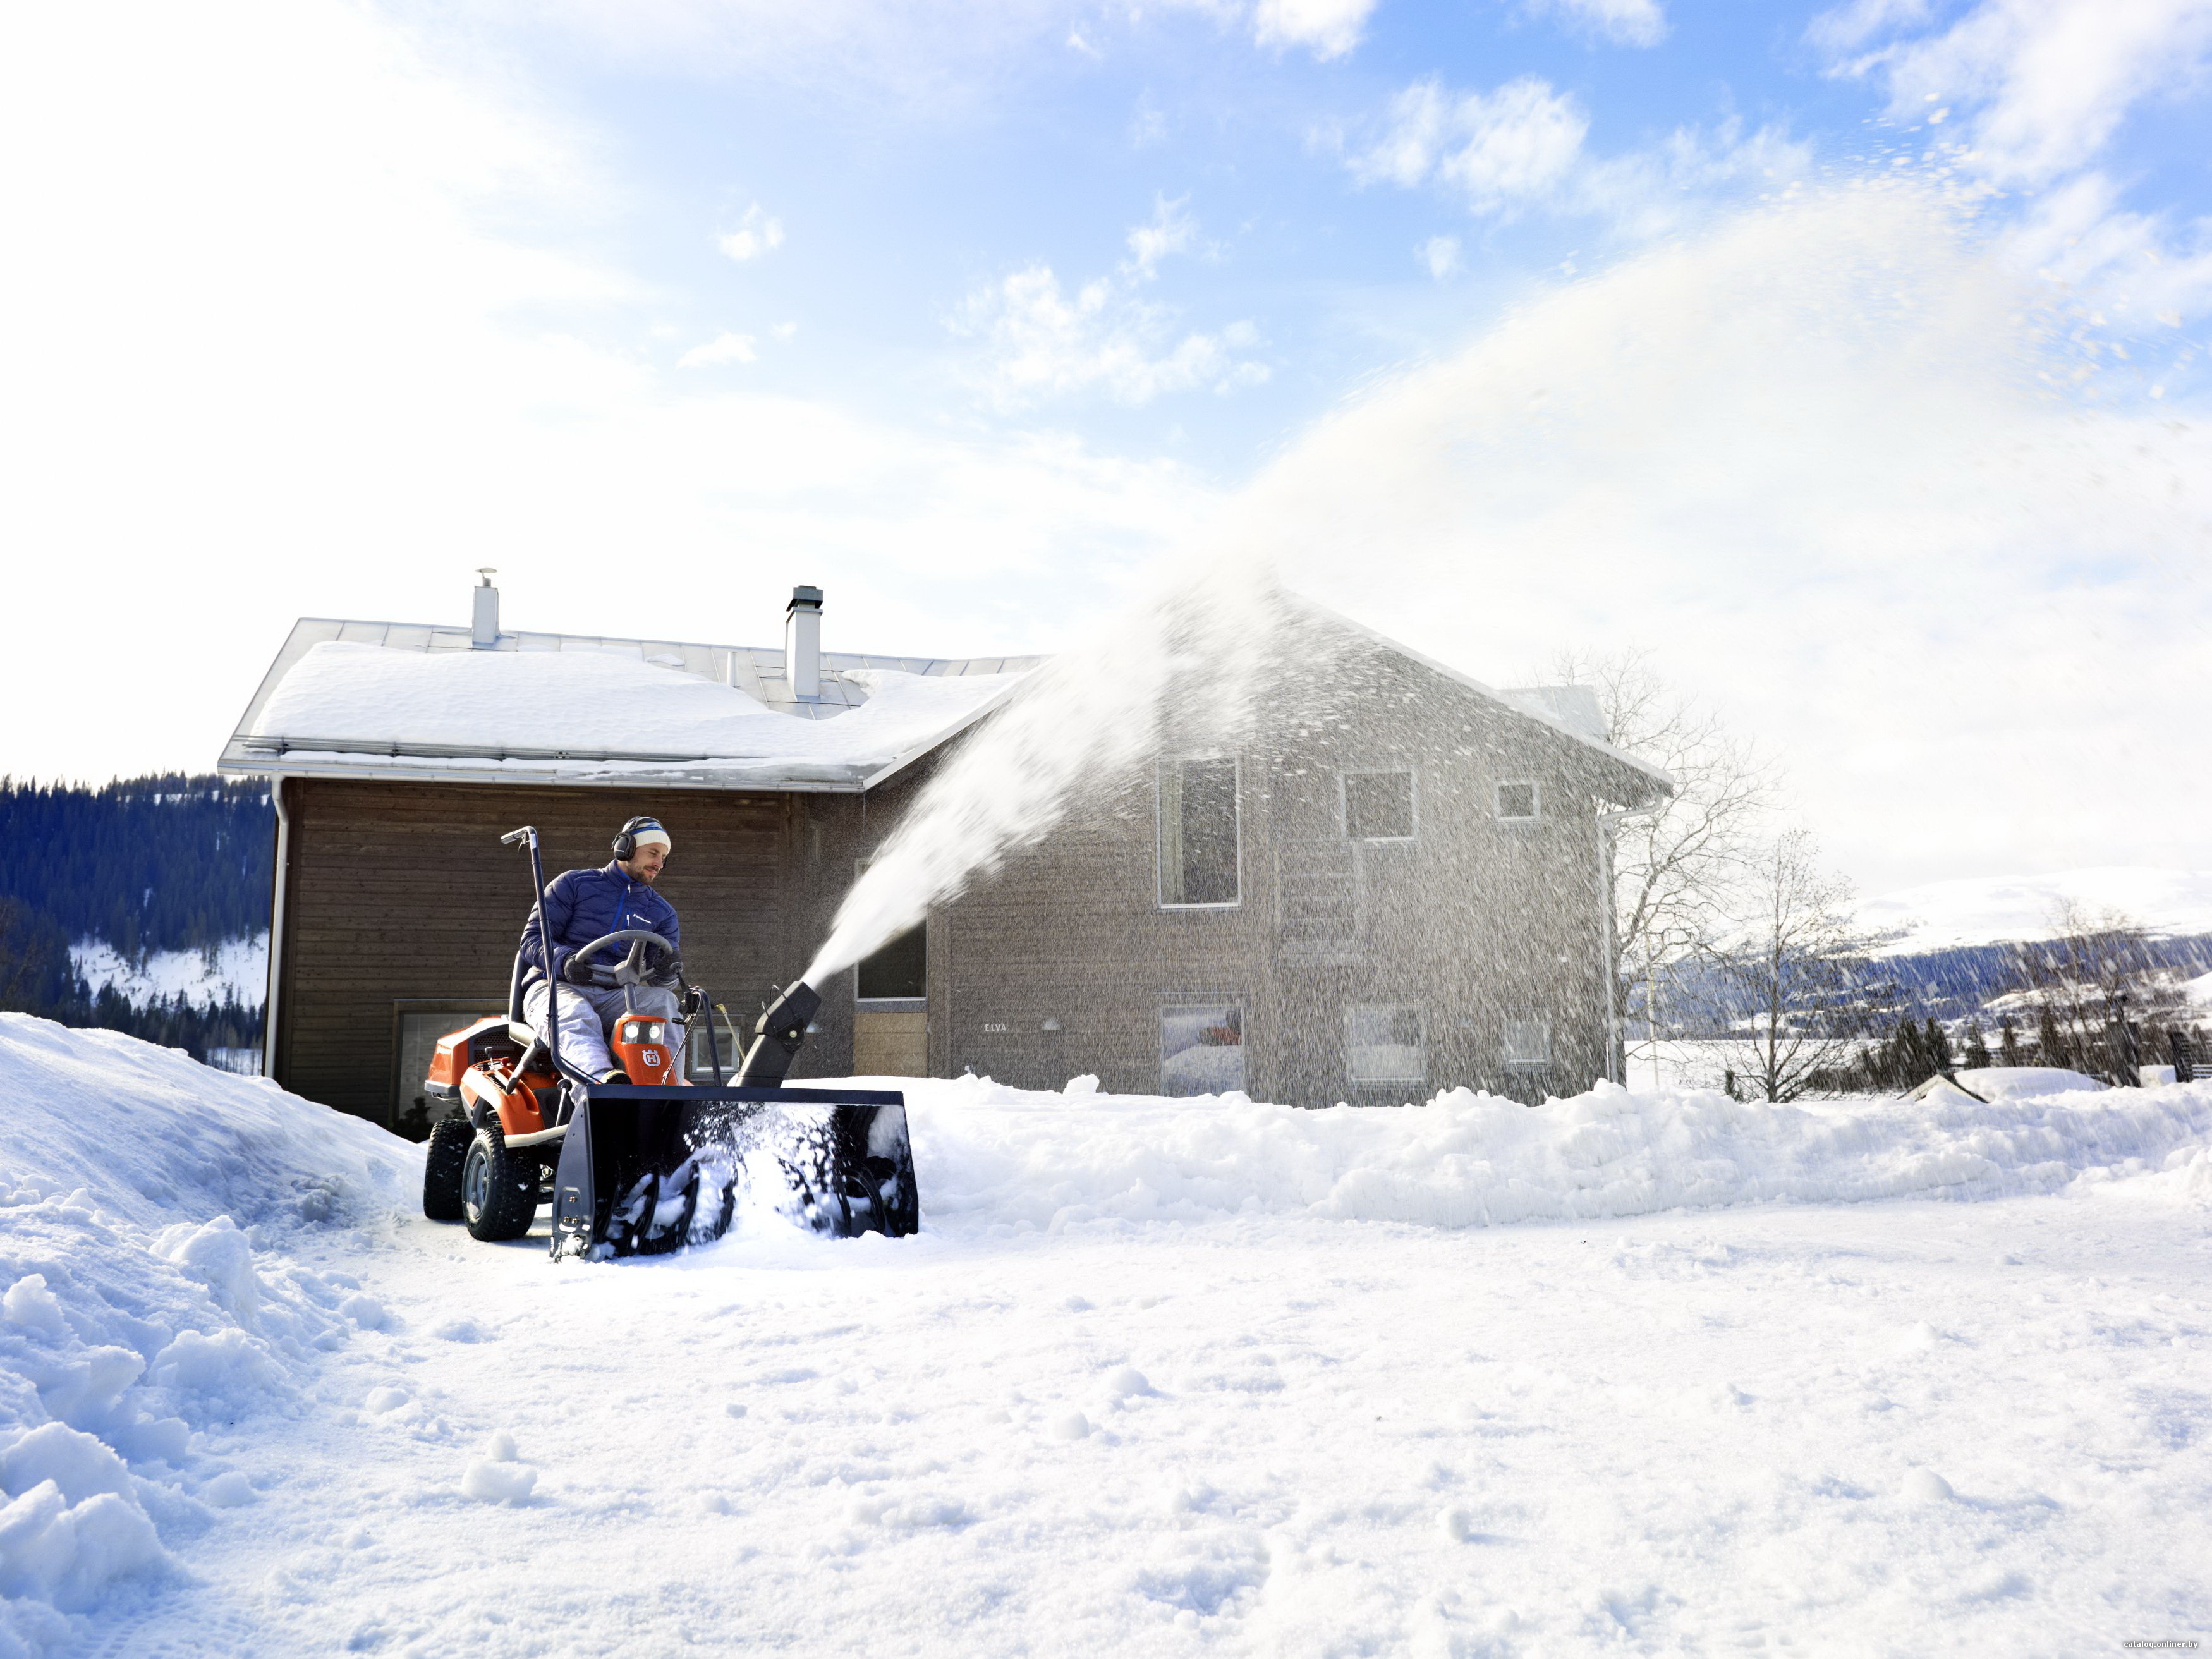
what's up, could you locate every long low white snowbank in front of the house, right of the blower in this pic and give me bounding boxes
[905,1073,2212,1232]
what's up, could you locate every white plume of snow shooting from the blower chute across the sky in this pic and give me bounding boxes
[810,181,2212,982]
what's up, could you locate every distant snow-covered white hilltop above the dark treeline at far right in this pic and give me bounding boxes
[1858,865,2212,956]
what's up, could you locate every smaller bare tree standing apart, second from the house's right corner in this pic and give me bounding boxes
[1699,830,1867,1102]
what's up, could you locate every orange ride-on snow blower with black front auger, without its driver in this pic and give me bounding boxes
[423,825,920,1261]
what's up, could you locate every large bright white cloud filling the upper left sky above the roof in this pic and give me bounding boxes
[0,0,1215,777]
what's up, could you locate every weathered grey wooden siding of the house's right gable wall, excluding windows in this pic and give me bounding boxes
[898,628,1622,1106]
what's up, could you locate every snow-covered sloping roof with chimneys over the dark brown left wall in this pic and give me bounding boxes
[221,617,1044,792]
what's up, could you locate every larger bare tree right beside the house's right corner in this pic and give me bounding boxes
[1548,650,1777,1071]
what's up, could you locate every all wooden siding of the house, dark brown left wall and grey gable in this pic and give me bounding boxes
[277,641,1632,1119]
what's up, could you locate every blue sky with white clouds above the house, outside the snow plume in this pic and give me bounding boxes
[0,0,2212,885]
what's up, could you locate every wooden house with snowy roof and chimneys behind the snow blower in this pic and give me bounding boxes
[221,578,1670,1126]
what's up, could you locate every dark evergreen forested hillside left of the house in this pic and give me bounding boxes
[0,774,272,1055]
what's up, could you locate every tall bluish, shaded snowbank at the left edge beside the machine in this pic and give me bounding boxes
[0,1013,420,1659]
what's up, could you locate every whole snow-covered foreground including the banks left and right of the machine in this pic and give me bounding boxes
[0,1016,2212,1655]
